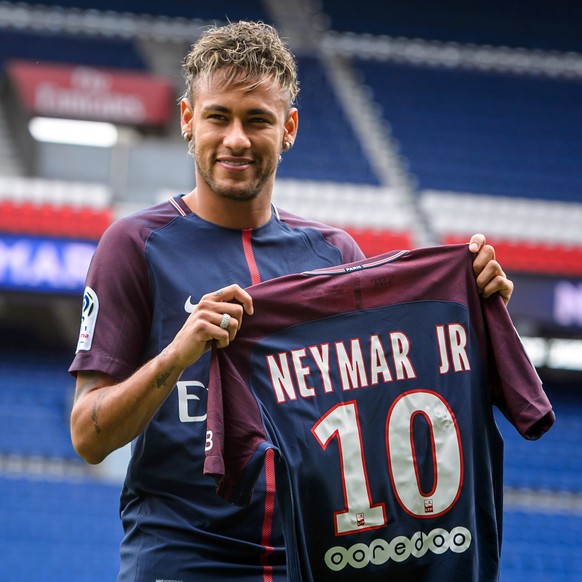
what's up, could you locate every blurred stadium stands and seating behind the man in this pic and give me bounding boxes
[0,0,582,582]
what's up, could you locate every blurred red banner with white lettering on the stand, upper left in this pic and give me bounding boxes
[7,61,173,125]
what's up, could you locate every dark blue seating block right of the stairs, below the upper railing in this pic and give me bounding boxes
[357,60,582,202]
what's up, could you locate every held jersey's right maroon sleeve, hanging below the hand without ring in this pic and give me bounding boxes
[483,294,555,440]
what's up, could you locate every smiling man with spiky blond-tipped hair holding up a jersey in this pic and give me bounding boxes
[70,22,513,582]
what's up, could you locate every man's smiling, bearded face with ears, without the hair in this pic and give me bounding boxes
[182,71,297,206]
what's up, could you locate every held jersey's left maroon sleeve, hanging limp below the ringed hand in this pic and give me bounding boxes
[204,348,278,505]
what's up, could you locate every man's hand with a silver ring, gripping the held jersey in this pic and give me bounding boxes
[164,285,253,368]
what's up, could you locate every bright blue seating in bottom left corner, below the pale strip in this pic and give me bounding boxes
[0,475,122,582]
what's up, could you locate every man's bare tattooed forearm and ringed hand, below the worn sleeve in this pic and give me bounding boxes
[71,285,252,463]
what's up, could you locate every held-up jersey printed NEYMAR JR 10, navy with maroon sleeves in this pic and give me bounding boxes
[205,245,554,582]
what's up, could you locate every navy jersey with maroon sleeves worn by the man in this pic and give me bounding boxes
[70,196,363,582]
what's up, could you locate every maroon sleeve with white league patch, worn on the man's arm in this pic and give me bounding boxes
[69,219,151,380]
